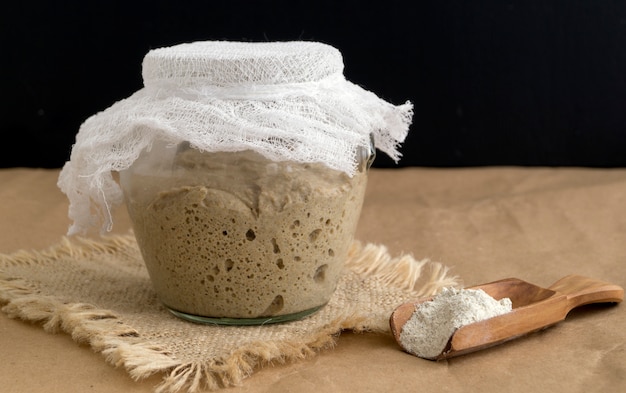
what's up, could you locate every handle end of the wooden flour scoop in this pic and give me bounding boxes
[549,274,624,311]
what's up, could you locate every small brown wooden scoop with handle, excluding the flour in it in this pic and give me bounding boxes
[389,275,624,360]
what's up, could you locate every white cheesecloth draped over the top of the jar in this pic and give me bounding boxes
[58,41,413,235]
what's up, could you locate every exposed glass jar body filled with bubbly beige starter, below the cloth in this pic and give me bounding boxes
[120,141,375,325]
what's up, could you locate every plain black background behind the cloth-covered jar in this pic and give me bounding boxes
[0,0,626,168]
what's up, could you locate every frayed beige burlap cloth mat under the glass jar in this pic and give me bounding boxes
[0,234,460,393]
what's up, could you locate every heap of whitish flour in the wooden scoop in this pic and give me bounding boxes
[400,288,512,358]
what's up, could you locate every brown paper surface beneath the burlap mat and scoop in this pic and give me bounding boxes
[0,168,626,392]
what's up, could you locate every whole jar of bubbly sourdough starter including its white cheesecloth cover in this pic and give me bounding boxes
[58,41,413,325]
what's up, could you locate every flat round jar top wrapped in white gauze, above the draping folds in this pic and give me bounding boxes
[142,41,344,86]
